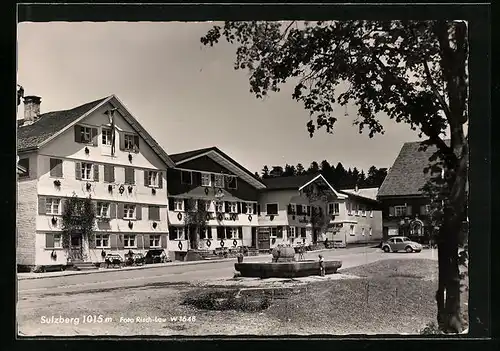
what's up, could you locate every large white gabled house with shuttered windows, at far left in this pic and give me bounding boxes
[16,95,174,266]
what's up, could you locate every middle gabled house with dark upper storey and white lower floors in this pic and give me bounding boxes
[167,147,265,258]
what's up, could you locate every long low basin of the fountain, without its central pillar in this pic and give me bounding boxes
[234,260,342,278]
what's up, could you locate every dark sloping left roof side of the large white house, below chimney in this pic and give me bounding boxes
[17,97,108,151]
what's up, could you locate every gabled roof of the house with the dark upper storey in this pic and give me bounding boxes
[170,146,265,189]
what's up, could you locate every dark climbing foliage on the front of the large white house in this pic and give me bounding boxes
[62,194,96,258]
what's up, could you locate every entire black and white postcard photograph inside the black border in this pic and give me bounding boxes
[16,6,478,337]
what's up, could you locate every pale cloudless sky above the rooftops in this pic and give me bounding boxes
[17,22,419,173]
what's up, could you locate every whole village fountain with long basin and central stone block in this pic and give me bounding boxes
[234,246,342,278]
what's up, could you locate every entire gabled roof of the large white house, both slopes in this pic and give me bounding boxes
[17,95,175,167]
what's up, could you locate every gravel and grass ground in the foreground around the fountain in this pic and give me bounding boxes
[17,259,467,336]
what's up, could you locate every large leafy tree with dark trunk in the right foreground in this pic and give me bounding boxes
[201,20,469,332]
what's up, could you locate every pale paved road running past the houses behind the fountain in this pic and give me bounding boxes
[18,247,437,299]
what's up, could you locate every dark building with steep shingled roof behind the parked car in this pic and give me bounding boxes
[377,141,436,242]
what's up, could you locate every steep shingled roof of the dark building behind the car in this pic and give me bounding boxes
[377,140,449,197]
